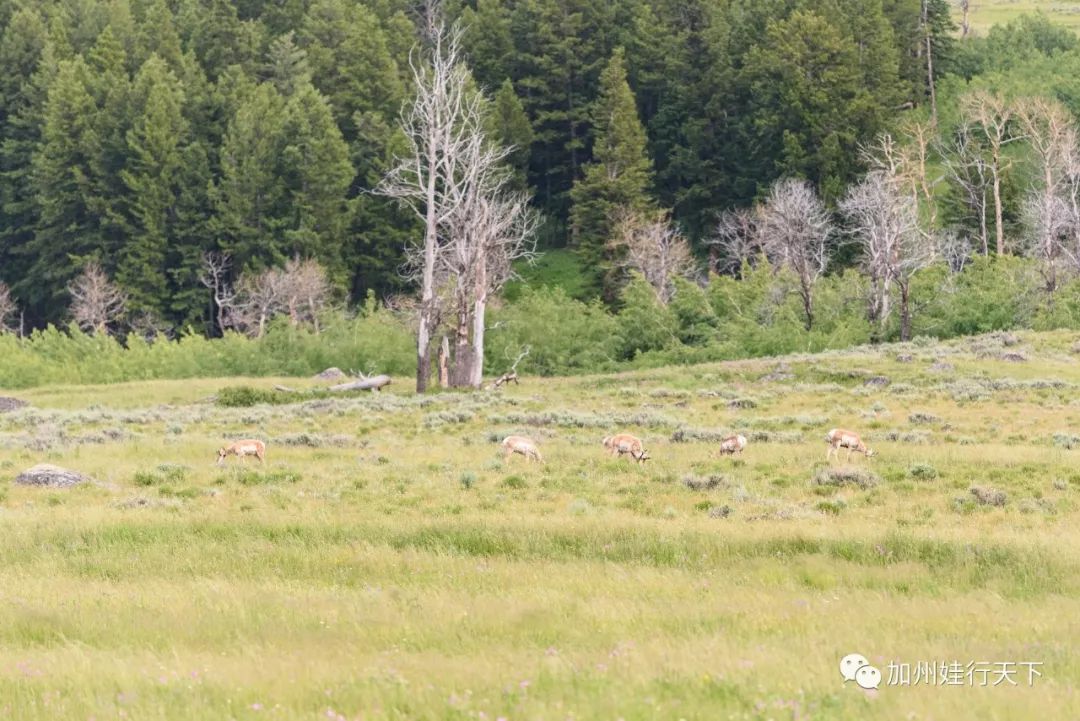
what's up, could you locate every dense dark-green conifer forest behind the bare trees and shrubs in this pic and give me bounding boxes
[0,0,954,334]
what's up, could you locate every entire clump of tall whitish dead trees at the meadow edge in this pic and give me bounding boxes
[376,11,537,392]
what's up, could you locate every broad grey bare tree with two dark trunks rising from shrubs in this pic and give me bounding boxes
[840,171,934,341]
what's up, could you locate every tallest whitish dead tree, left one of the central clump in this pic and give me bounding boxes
[375,16,483,393]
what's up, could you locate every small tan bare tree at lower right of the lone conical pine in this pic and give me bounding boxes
[612,210,697,304]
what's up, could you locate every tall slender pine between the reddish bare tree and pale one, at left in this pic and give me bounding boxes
[117,55,187,317]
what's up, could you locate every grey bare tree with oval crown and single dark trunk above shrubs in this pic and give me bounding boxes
[759,178,833,330]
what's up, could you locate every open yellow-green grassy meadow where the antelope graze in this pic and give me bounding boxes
[0,334,1080,721]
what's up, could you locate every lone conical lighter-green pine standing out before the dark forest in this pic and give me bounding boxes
[571,49,652,298]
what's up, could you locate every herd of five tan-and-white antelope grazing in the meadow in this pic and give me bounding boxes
[217,428,874,465]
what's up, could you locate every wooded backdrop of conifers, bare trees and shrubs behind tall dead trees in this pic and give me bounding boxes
[6,0,1080,384]
